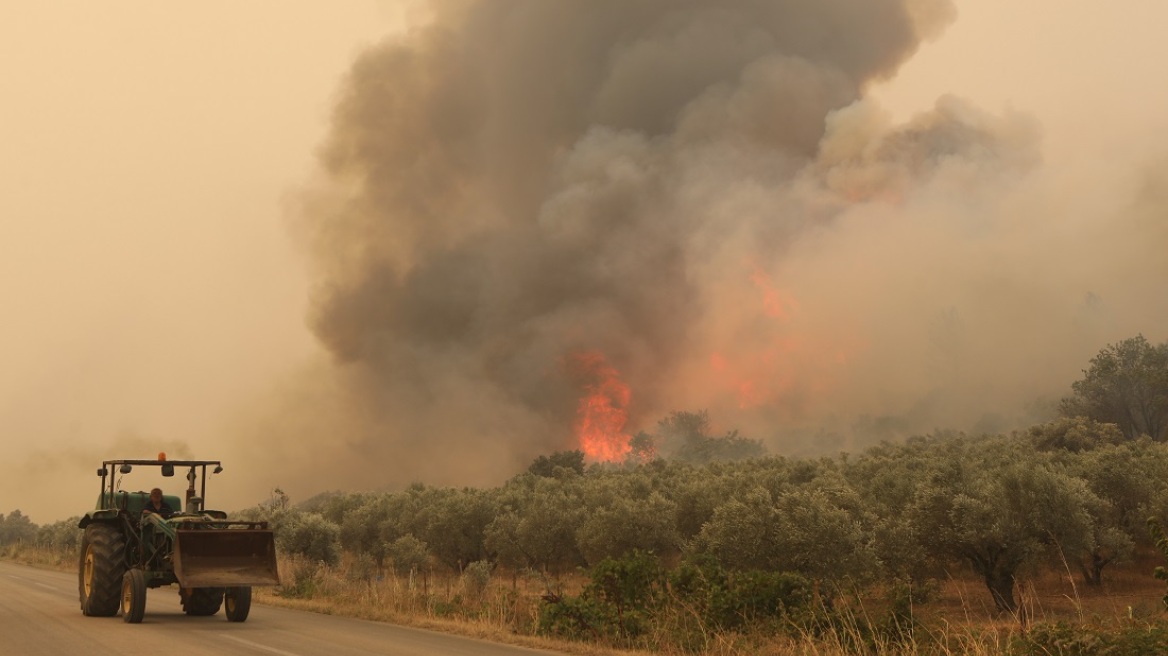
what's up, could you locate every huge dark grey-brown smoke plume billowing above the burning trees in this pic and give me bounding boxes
[260,0,1163,486]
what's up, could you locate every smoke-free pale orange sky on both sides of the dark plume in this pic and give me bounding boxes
[0,0,1168,523]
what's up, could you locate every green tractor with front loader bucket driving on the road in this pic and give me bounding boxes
[77,453,279,623]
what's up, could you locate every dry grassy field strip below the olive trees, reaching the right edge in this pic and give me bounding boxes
[0,545,1168,656]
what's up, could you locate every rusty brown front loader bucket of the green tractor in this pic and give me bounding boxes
[174,528,280,587]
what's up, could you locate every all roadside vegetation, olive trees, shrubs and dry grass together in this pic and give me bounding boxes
[0,337,1168,654]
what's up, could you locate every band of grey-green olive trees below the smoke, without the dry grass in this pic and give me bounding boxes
[237,336,1168,613]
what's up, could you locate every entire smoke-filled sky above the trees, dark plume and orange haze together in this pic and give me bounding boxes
[0,0,1168,522]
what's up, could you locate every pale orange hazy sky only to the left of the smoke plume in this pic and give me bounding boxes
[0,1,399,521]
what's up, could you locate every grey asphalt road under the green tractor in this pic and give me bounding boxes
[0,561,565,656]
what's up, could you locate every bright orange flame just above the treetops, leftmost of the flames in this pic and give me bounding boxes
[570,351,632,462]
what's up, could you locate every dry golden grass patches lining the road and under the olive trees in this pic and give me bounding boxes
[0,546,1164,656]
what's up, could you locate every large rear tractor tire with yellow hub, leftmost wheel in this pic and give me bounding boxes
[77,524,126,617]
